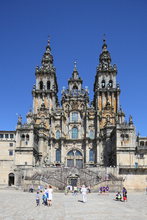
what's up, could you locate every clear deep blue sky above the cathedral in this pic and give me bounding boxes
[0,0,147,136]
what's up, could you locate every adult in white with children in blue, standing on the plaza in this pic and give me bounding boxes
[36,185,53,206]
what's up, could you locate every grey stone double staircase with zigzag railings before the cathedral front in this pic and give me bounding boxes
[25,167,121,190]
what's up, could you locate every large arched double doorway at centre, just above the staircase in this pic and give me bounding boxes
[67,150,83,168]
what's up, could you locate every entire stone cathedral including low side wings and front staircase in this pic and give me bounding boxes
[0,40,147,189]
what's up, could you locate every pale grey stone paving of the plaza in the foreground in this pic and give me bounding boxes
[0,190,147,220]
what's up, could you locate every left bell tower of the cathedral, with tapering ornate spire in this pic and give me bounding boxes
[32,40,58,114]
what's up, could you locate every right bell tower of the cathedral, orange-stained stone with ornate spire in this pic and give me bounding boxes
[94,40,120,128]
